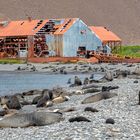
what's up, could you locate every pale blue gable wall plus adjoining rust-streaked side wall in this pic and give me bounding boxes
[46,19,102,57]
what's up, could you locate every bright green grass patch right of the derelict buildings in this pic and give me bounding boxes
[115,46,140,58]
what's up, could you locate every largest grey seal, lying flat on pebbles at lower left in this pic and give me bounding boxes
[0,112,64,128]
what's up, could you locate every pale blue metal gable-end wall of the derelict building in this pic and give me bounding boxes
[63,19,102,57]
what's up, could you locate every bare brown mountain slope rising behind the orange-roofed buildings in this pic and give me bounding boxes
[0,0,140,45]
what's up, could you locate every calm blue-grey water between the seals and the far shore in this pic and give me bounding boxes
[0,72,89,95]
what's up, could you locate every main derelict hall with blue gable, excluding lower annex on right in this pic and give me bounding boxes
[0,18,102,57]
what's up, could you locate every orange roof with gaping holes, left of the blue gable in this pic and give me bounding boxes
[0,18,77,37]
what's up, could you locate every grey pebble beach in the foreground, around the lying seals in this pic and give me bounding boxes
[0,63,140,140]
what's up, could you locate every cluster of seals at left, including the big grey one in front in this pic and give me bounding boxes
[0,88,69,127]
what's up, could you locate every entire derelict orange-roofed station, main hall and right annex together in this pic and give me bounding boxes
[0,17,127,62]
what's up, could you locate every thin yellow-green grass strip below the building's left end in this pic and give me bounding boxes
[0,58,25,64]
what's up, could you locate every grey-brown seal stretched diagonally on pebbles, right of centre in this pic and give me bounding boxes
[82,91,117,104]
